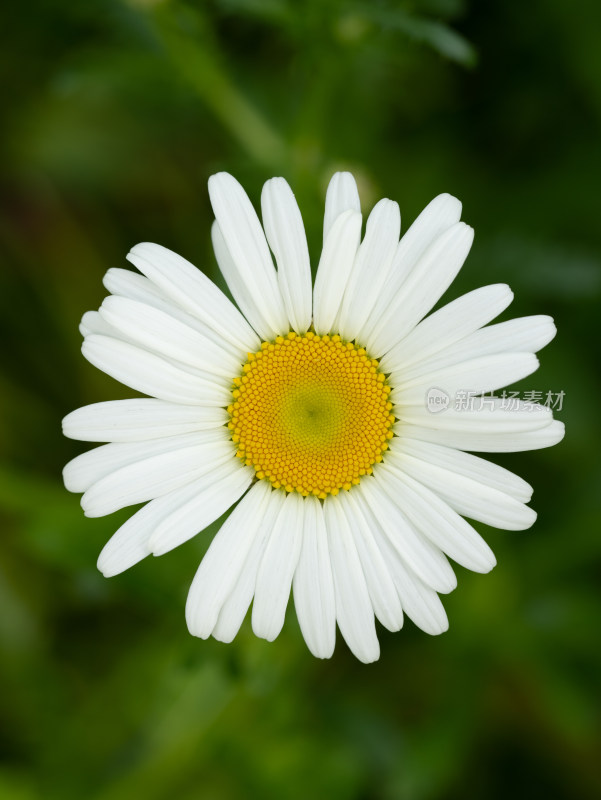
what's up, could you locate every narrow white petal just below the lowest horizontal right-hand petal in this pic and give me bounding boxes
[387,437,532,503]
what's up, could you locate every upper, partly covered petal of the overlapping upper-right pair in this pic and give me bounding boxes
[362,194,461,341]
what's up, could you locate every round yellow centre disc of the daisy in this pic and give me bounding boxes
[228,332,395,499]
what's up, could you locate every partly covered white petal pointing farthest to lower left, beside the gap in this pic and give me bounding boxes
[98,476,211,578]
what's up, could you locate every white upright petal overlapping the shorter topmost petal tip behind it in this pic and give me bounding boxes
[313,211,361,335]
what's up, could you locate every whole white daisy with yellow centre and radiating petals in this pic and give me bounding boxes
[63,173,563,662]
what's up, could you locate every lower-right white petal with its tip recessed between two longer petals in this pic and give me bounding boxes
[357,470,457,592]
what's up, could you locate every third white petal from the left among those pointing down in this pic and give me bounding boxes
[252,492,303,642]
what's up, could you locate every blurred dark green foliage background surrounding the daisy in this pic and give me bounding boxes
[0,0,601,800]
